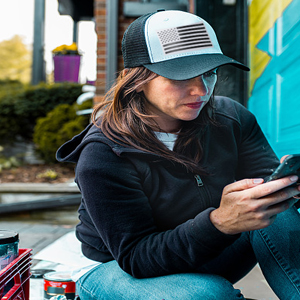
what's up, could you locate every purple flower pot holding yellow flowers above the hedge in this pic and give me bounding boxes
[53,55,81,82]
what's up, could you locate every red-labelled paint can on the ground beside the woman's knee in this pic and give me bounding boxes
[44,272,76,300]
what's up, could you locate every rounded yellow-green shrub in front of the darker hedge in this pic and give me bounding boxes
[33,100,92,163]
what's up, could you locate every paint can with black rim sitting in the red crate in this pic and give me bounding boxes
[0,230,19,270]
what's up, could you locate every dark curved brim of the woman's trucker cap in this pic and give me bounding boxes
[144,54,250,80]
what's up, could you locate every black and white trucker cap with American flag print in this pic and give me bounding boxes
[122,10,249,80]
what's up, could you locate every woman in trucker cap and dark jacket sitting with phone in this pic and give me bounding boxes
[57,11,300,300]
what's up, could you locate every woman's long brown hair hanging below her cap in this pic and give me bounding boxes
[92,67,215,174]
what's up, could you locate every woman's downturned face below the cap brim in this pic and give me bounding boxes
[141,69,217,132]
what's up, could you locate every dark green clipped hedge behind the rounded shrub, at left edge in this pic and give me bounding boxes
[0,82,82,141]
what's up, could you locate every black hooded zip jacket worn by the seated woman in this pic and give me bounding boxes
[57,97,278,278]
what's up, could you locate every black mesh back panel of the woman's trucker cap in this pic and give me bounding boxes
[122,13,154,68]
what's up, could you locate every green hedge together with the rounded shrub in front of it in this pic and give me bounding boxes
[0,79,93,163]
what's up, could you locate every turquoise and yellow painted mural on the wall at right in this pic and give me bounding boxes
[248,0,300,157]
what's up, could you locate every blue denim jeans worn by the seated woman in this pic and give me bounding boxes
[76,207,300,300]
